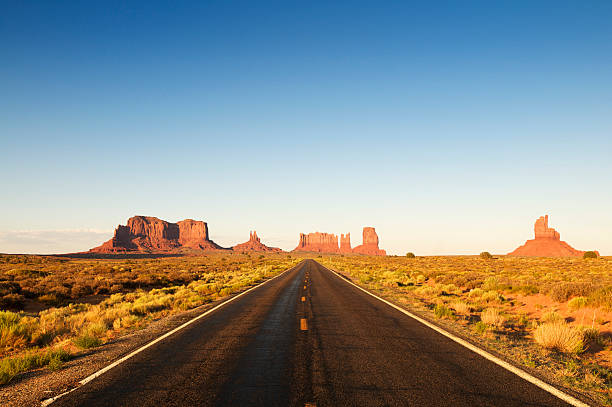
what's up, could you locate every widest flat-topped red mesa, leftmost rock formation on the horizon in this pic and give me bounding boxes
[90,216,223,253]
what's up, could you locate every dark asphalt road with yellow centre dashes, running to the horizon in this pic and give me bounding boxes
[52,260,567,407]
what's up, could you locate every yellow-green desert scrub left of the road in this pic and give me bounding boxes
[0,253,299,384]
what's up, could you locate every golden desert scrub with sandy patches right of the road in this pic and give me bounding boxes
[317,252,612,405]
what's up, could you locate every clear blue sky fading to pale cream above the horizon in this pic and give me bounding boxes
[0,0,612,255]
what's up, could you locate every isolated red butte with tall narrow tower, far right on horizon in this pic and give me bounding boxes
[508,215,584,257]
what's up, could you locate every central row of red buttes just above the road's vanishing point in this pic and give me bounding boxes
[293,227,387,256]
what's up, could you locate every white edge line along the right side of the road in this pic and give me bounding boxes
[323,266,589,407]
